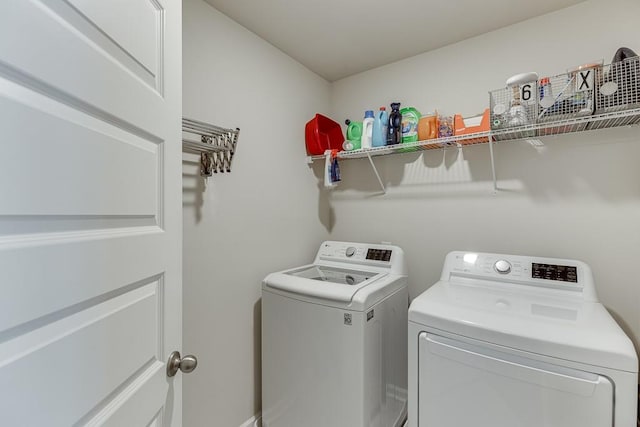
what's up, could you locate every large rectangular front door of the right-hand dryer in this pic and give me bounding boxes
[417,332,614,427]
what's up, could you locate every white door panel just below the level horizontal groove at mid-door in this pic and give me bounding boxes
[0,231,164,334]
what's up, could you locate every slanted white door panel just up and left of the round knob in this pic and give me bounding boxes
[0,282,164,426]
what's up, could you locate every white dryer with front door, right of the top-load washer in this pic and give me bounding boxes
[409,252,638,427]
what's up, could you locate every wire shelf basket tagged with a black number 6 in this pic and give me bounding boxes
[489,81,538,140]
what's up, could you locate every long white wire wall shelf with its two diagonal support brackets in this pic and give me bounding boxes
[307,108,640,193]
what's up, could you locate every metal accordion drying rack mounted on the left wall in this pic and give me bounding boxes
[182,117,240,177]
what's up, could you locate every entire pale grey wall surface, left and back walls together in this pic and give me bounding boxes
[183,0,640,427]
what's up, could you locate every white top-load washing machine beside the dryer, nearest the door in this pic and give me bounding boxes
[262,241,408,427]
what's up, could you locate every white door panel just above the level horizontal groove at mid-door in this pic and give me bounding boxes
[0,83,163,217]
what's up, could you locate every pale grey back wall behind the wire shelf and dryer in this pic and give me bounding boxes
[330,0,640,348]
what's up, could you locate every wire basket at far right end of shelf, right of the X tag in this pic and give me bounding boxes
[589,56,640,129]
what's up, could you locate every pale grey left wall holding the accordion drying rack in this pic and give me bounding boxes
[183,0,329,427]
